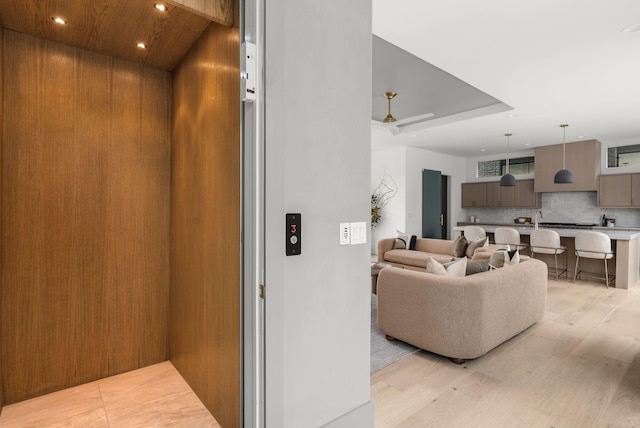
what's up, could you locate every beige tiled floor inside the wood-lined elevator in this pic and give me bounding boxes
[0,361,220,428]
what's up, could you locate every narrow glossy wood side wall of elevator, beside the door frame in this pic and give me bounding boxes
[169,17,241,427]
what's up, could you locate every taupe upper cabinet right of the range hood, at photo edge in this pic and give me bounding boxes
[598,173,640,208]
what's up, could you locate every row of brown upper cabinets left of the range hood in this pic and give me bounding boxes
[462,180,536,208]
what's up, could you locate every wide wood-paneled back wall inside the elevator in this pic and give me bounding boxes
[2,31,171,403]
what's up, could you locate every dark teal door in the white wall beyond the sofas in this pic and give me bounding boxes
[422,169,446,239]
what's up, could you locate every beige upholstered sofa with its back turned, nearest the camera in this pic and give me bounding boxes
[377,259,547,363]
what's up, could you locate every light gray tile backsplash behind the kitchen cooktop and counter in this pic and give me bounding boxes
[458,192,640,227]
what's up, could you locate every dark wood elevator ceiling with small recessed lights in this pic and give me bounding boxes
[0,0,211,71]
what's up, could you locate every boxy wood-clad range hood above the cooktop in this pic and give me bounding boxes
[535,140,600,193]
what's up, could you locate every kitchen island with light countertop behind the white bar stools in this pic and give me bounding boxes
[453,223,640,289]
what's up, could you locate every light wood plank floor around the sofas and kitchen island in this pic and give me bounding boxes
[371,280,640,428]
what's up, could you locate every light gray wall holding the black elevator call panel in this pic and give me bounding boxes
[265,0,373,428]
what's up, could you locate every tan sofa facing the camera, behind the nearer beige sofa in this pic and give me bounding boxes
[378,238,500,271]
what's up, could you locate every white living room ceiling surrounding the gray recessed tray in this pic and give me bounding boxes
[372,0,640,157]
